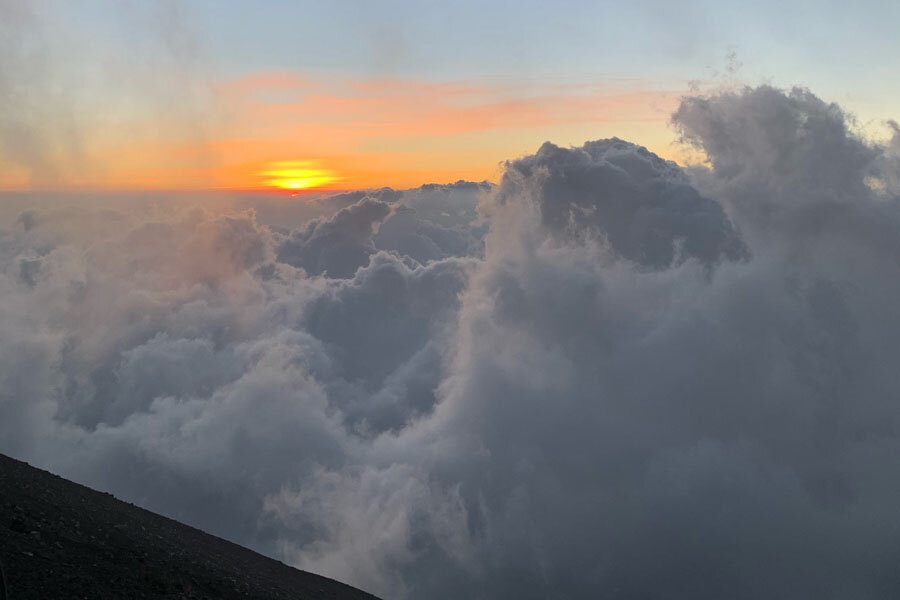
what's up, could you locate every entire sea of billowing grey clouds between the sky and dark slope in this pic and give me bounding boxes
[0,86,900,600]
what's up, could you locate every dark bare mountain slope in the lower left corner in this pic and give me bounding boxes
[0,454,376,600]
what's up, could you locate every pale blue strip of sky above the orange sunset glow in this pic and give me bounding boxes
[58,0,900,123]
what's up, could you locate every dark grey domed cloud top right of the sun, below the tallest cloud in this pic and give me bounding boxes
[498,138,745,268]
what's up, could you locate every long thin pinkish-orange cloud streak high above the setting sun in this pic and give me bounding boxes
[222,73,678,139]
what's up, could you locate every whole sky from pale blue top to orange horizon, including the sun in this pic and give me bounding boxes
[0,0,900,190]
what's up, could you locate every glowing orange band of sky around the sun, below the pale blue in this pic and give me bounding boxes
[0,72,682,190]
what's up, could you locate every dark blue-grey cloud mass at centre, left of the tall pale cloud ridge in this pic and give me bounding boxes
[303,253,475,433]
